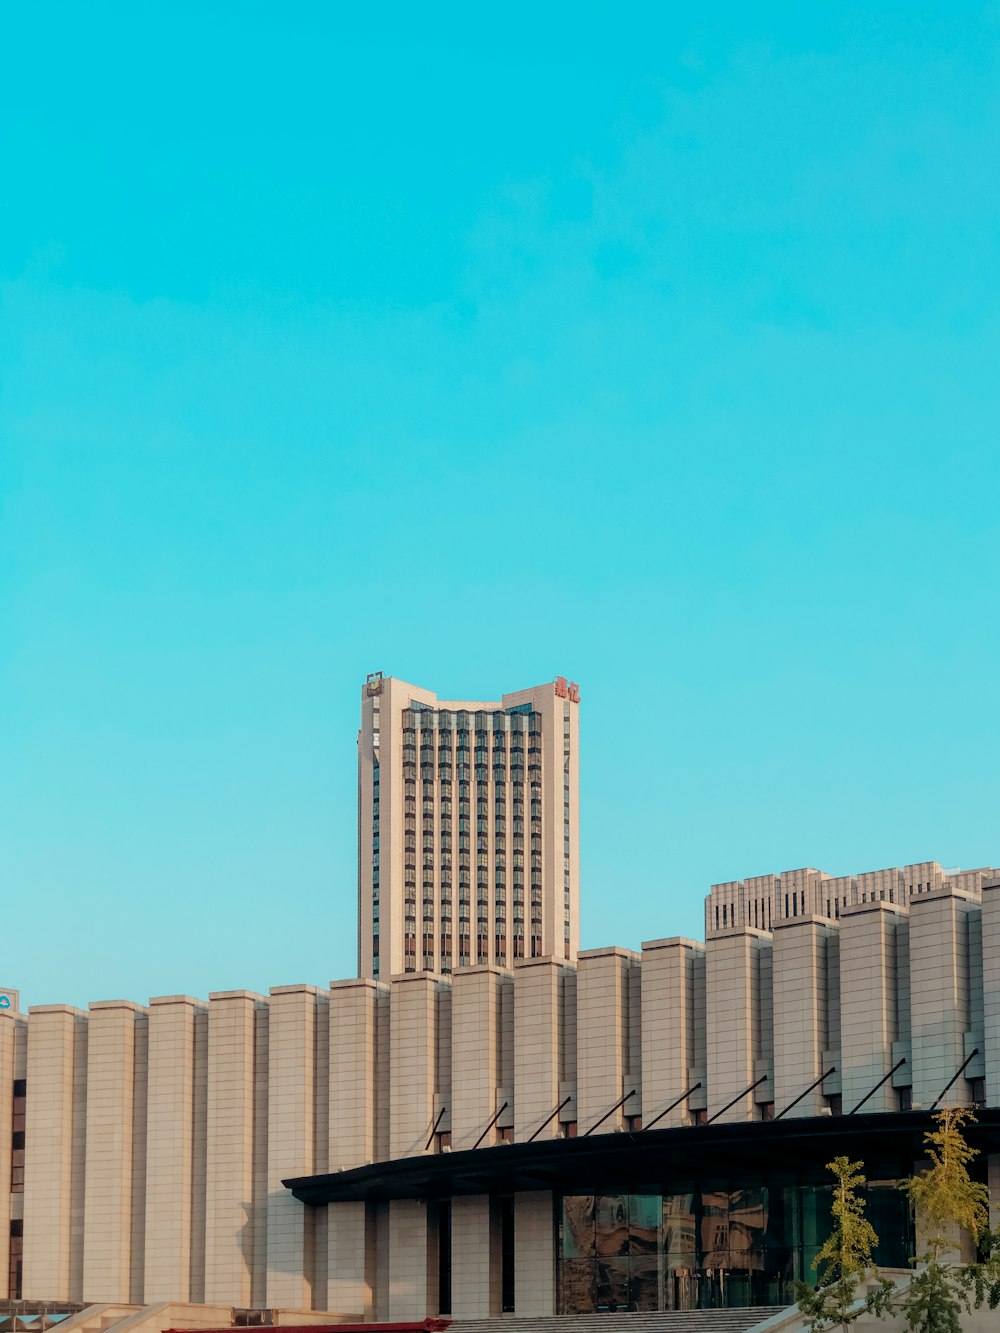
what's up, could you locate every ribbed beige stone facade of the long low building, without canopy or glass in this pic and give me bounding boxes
[0,882,1000,1318]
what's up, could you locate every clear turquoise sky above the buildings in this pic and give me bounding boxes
[0,0,1000,1004]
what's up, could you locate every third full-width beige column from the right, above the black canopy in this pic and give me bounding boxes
[773,916,840,1118]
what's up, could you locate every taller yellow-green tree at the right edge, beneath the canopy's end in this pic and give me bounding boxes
[901,1106,1000,1333]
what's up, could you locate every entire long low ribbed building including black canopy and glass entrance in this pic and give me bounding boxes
[0,863,1000,1329]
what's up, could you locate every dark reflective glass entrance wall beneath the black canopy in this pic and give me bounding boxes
[557,1174,913,1314]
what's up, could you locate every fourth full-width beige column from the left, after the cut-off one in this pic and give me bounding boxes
[205,990,264,1306]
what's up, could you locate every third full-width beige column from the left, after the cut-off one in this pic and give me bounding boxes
[143,996,204,1304]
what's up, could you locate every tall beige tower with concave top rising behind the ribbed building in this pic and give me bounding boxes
[357,672,580,980]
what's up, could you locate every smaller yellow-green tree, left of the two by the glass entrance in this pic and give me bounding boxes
[799,1157,892,1333]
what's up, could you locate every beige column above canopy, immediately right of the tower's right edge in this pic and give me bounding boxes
[576,948,641,1134]
